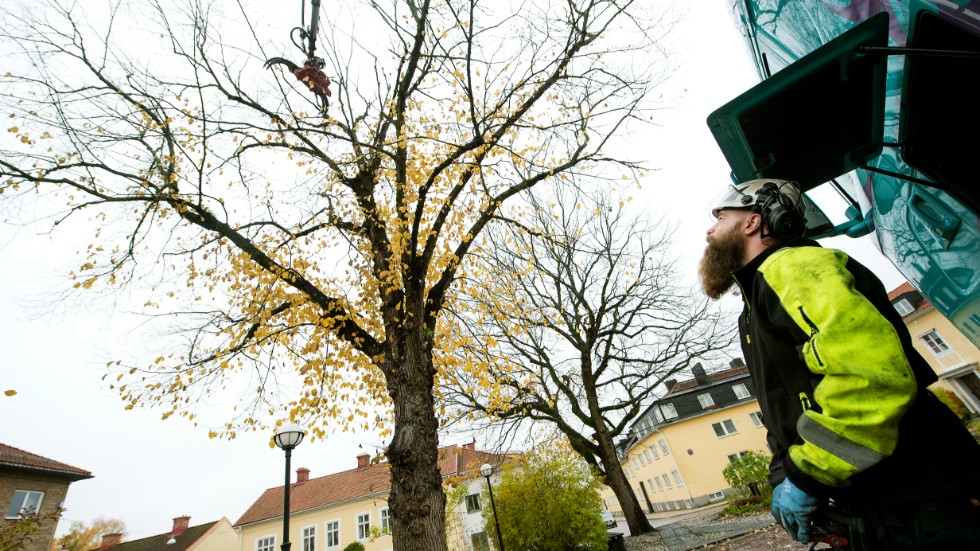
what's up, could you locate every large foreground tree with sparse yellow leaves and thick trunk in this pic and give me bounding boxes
[0,0,662,549]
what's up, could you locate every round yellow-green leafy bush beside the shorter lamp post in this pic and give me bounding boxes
[480,444,609,551]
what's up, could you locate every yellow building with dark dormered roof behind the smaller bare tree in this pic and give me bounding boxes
[603,359,769,513]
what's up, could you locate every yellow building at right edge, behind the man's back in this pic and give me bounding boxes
[888,283,980,415]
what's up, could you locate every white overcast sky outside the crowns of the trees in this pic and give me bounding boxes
[0,0,903,540]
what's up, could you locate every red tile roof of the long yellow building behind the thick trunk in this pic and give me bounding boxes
[235,445,514,526]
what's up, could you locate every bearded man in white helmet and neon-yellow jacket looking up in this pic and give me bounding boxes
[700,179,980,550]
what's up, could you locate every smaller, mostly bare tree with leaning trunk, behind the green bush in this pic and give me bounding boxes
[444,186,733,534]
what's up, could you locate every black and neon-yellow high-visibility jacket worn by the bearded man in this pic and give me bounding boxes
[732,240,980,500]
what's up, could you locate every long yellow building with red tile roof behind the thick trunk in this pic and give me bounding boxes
[234,443,512,551]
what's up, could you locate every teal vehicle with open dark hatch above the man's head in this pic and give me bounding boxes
[707,0,980,346]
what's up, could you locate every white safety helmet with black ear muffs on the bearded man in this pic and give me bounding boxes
[711,178,806,239]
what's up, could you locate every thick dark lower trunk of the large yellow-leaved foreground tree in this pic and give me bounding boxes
[385,327,446,551]
